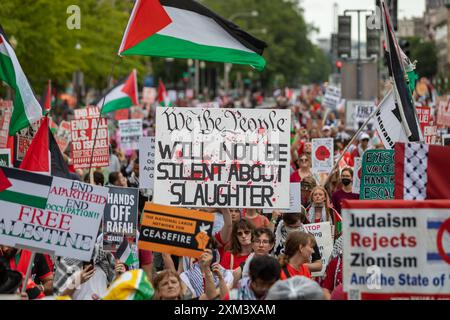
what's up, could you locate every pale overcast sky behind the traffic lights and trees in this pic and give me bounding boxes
[301,0,425,41]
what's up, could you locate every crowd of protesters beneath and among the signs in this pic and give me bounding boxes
[0,83,438,300]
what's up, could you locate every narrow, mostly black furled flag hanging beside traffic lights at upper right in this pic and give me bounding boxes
[381,0,423,142]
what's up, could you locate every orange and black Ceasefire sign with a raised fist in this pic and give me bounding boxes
[138,202,214,258]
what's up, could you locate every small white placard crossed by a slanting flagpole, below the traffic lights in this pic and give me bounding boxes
[345,100,375,130]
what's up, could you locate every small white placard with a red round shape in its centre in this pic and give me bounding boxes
[311,138,334,173]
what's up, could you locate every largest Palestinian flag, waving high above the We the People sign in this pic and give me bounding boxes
[119,0,267,70]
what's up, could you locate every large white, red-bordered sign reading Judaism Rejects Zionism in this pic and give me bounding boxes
[342,200,450,299]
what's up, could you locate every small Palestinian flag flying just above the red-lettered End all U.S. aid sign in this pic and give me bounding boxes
[97,70,139,114]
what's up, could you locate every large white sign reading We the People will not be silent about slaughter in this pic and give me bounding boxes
[154,108,291,209]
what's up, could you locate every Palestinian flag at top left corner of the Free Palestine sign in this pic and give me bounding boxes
[0,167,52,209]
